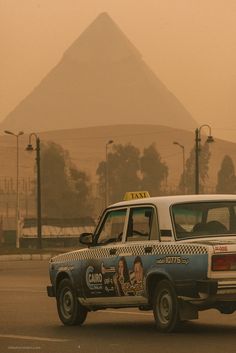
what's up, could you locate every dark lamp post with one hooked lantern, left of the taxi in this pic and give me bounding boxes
[26,132,42,249]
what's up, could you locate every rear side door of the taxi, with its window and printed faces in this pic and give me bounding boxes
[114,205,159,303]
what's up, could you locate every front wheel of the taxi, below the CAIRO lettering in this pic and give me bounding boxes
[56,278,88,326]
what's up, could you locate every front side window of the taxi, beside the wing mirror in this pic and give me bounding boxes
[96,209,126,245]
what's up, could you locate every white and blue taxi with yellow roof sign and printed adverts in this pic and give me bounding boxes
[47,192,236,332]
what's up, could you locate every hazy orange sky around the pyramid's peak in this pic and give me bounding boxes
[0,0,236,142]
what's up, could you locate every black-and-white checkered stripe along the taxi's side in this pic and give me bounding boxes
[53,243,207,262]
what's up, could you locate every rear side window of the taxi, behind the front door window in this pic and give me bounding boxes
[126,207,153,241]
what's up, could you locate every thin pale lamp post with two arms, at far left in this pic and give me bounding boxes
[4,130,24,249]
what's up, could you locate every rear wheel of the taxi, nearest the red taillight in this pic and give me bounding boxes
[153,280,179,333]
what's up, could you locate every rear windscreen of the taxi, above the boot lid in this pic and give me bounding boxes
[172,201,236,239]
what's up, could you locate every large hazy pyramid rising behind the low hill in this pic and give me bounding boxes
[1,13,197,132]
